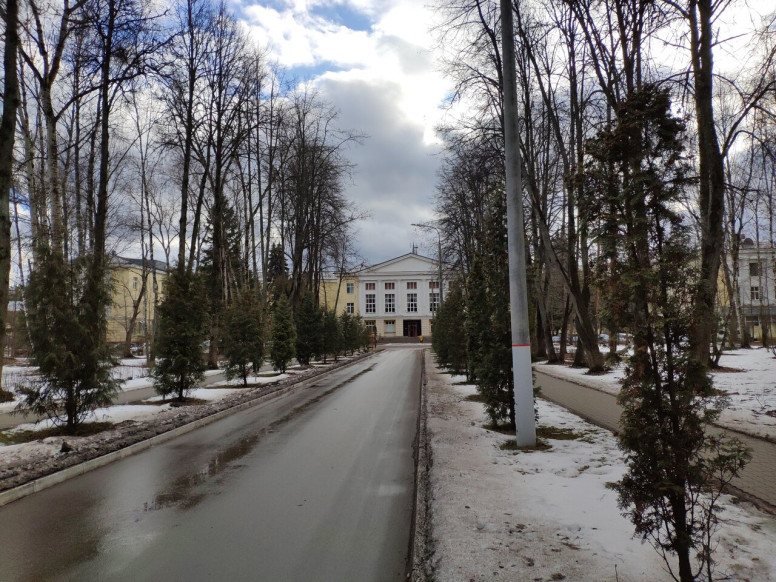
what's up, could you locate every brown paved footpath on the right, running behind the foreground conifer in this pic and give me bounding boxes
[534,365,776,510]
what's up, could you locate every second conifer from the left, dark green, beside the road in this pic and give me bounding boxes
[153,269,208,401]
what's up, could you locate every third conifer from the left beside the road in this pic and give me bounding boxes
[223,288,264,386]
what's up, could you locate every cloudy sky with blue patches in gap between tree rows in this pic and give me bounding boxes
[236,0,449,263]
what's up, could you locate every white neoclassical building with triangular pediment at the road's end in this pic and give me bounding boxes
[357,252,447,339]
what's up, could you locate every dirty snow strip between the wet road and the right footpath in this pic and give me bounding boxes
[427,359,776,582]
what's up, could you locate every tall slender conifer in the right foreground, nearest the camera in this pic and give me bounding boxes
[587,85,748,582]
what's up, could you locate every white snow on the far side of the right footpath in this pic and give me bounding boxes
[539,348,776,440]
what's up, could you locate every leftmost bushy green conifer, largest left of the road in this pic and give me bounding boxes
[19,249,117,432]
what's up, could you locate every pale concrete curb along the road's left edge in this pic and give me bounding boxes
[0,352,376,507]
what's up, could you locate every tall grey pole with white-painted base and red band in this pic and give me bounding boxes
[501,0,536,447]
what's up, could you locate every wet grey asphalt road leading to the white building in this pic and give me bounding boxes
[0,347,422,582]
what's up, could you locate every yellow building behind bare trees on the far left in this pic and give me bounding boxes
[107,257,167,346]
